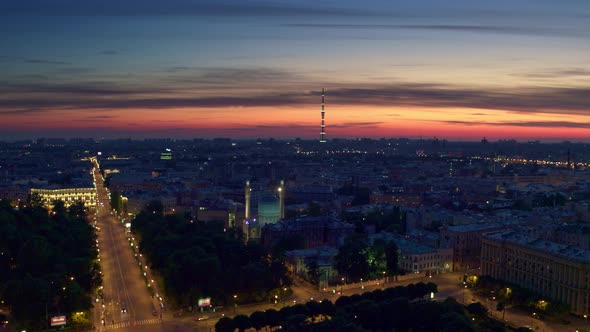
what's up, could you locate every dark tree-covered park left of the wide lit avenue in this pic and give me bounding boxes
[0,195,102,330]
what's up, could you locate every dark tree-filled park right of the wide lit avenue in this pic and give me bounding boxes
[132,202,290,306]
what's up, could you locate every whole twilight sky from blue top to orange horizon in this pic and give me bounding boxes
[0,0,590,141]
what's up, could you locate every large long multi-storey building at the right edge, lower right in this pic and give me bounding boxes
[481,231,590,315]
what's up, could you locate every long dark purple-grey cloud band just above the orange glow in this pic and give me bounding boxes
[0,67,590,116]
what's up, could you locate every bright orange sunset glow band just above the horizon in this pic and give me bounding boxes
[4,104,590,140]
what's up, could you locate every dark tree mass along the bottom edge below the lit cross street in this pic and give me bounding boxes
[215,283,492,332]
